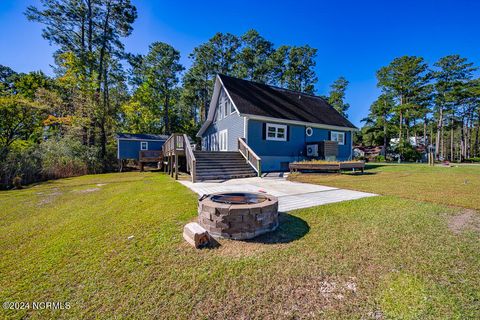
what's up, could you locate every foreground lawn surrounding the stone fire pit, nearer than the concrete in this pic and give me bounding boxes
[0,173,480,319]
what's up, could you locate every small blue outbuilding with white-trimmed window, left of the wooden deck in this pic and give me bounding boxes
[117,133,168,160]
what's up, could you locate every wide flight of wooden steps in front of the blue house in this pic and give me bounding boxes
[193,151,257,181]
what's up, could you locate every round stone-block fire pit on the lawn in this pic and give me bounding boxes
[198,192,278,240]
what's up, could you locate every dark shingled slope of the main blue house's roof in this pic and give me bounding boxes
[219,75,356,128]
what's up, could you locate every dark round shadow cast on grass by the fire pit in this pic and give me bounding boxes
[245,212,310,244]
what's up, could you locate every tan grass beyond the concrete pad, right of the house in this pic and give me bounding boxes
[289,164,480,209]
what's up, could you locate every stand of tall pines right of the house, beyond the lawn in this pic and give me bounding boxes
[357,54,480,161]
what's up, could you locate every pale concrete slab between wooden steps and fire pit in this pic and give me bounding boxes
[178,177,376,212]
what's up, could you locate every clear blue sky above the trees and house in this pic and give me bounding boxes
[0,0,480,125]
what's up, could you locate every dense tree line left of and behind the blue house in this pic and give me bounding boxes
[0,0,348,188]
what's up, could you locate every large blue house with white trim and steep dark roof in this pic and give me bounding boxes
[197,75,358,172]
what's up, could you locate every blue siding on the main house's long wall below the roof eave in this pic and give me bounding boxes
[247,120,351,172]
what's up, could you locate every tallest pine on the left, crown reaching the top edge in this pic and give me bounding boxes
[26,0,137,166]
